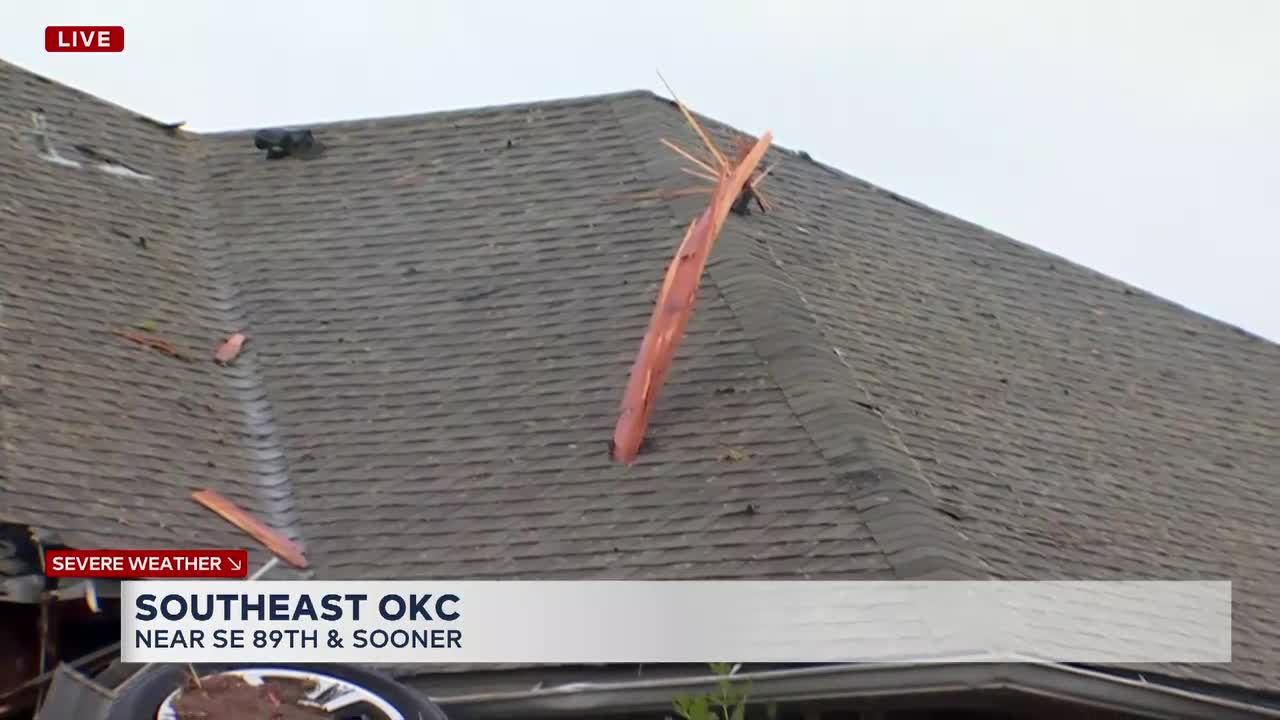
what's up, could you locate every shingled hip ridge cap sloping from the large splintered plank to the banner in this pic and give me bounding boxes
[613,96,989,579]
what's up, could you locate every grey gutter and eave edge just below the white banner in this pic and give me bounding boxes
[424,657,1280,720]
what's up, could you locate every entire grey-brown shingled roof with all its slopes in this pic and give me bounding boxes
[0,63,1280,687]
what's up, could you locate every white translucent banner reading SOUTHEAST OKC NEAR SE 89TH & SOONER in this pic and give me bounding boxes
[120,580,1231,664]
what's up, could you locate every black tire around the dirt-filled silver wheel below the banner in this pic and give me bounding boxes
[106,662,448,720]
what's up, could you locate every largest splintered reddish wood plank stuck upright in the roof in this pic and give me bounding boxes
[611,79,773,462]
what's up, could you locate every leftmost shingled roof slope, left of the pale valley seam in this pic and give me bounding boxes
[0,57,302,561]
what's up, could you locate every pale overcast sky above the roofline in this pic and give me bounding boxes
[0,0,1280,341]
